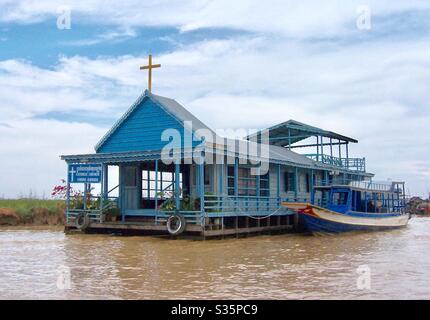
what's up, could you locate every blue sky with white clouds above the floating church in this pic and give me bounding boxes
[0,0,430,198]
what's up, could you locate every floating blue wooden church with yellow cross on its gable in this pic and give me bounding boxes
[61,55,373,237]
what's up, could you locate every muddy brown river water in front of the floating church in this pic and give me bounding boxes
[0,218,430,299]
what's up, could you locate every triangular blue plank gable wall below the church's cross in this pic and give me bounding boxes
[97,98,198,153]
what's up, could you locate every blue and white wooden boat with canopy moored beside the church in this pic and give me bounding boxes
[283,182,410,233]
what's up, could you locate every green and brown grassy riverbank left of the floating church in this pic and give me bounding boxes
[0,199,64,225]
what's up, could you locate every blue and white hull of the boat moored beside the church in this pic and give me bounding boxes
[284,203,409,233]
